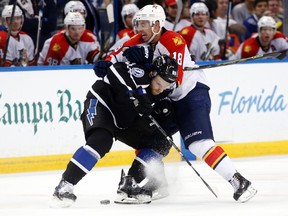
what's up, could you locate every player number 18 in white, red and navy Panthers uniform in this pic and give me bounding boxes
[107,4,257,202]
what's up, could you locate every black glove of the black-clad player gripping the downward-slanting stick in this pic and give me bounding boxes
[130,87,153,116]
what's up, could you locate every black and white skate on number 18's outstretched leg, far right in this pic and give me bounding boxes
[229,172,257,202]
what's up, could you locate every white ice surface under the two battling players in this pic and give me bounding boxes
[0,155,288,216]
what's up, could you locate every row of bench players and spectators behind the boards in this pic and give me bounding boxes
[0,0,288,66]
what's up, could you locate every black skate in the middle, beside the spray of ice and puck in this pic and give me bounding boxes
[114,170,152,204]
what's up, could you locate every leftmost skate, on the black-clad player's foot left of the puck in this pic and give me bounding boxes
[50,179,77,208]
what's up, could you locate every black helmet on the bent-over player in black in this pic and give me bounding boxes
[152,55,178,83]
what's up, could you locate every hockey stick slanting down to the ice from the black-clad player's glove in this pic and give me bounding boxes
[149,115,217,198]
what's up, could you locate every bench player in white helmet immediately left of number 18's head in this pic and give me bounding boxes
[116,4,139,41]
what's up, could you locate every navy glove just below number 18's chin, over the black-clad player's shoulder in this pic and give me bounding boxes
[123,46,154,66]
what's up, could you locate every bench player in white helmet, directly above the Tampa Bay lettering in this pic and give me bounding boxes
[38,12,100,65]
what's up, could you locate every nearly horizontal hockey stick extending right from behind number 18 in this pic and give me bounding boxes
[184,49,288,71]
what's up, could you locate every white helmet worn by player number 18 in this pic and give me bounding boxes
[135,4,166,29]
